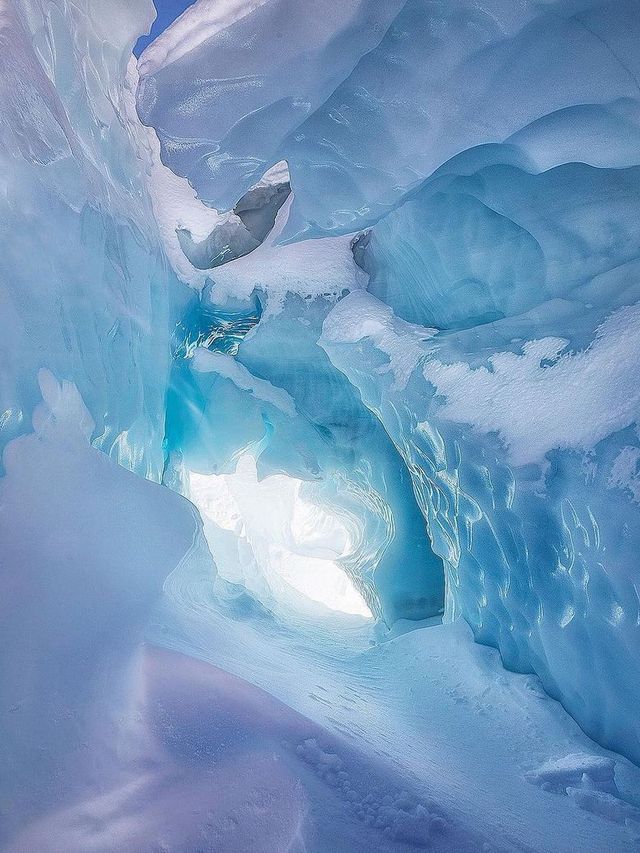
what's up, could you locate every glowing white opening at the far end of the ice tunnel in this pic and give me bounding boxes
[189,454,372,618]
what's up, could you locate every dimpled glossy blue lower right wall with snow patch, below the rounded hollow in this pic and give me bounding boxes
[321,284,640,758]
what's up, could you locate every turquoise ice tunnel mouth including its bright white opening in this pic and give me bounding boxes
[164,245,444,626]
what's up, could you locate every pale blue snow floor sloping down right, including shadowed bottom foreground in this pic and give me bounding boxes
[139,566,640,853]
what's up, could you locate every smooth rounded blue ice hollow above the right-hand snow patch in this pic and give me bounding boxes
[358,145,640,334]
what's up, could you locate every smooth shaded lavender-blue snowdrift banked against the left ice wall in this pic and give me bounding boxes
[0,371,199,849]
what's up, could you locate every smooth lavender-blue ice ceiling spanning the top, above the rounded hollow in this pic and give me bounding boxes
[138,0,640,238]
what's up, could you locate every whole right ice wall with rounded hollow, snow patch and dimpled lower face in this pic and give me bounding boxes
[332,145,640,759]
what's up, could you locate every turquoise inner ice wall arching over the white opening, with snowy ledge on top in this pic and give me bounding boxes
[166,236,444,624]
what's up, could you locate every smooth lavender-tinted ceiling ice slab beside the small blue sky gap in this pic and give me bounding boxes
[138,0,403,210]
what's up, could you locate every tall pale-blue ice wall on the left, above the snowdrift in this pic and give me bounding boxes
[0,0,178,480]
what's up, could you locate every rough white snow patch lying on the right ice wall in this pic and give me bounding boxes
[424,303,640,465]
